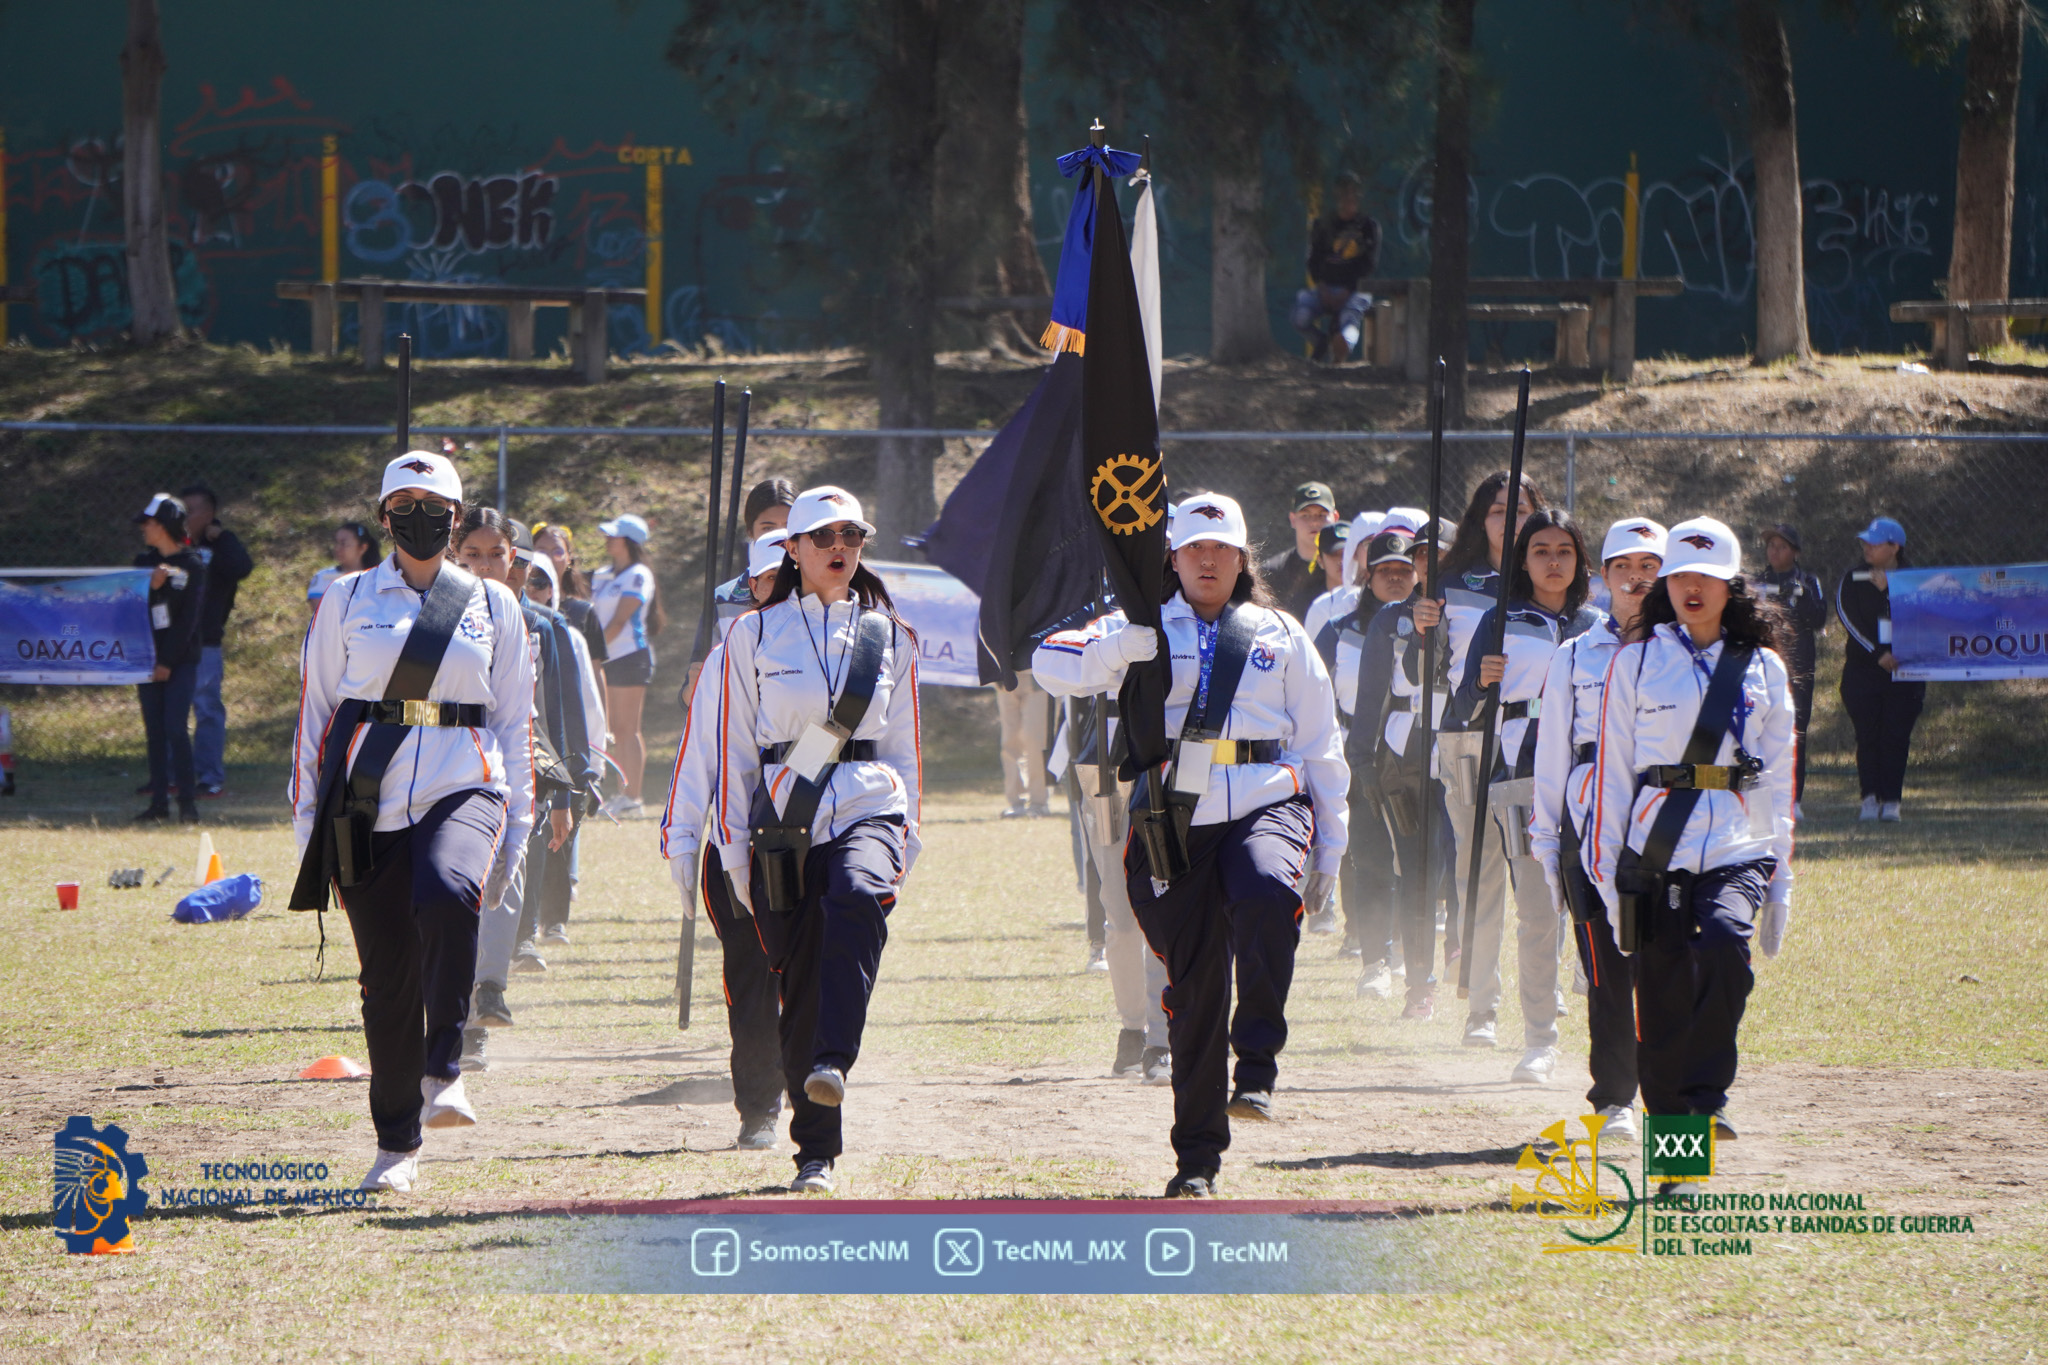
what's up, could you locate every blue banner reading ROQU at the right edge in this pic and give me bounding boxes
[1890,565,2048,681]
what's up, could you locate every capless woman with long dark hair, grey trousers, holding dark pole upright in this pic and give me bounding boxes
[1450,508,1599,1085]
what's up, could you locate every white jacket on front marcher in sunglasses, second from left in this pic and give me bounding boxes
[698,593,924,876]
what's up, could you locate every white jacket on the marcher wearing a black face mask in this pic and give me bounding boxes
[291,557,535,866]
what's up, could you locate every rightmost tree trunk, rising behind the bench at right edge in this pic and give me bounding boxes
[1948,0,2025,350]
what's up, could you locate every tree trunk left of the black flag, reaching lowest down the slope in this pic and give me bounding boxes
[868,0,942,559]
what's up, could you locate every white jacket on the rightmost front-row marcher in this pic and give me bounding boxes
[1585,622,1794,927]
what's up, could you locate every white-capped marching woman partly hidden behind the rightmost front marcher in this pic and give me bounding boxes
[1530,516,1665,1142]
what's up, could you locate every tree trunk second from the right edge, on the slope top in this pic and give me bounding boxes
[1735,0,1812,364]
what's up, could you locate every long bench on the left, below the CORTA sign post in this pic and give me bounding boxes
[276,278,647,385]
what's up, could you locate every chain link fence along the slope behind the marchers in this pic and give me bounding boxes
[0,422,2048,789]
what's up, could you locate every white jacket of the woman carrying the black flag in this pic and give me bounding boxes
[1032,593,1352,874]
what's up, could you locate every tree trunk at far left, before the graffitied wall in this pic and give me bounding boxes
[121,0,178,344]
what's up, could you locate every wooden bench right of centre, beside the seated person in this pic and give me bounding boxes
[1358,276,1686,383]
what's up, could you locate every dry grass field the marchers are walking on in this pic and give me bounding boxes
[0,769,2048,1361]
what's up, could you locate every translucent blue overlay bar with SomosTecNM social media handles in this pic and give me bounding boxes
[504,1201,1446,1293]
